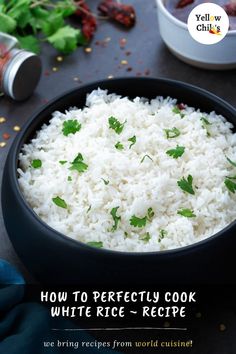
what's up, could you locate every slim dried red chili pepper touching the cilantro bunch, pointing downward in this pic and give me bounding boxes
[75,0,97,40]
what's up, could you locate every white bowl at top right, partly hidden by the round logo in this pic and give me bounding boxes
[157,0,236,70]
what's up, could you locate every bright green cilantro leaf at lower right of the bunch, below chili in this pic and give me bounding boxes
[47,26,81,54]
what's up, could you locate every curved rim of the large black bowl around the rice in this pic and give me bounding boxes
[9,77,236,257]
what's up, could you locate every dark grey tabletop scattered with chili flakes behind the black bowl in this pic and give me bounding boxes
[0,0,236,281]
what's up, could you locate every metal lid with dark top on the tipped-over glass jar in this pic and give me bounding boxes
[2,49,42,101]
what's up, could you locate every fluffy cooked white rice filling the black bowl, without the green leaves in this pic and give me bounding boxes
[18,89,236,252]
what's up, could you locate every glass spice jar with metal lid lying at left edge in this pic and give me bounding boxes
[0,32,42,101]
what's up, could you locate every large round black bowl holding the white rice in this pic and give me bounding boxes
[2,78,236,285]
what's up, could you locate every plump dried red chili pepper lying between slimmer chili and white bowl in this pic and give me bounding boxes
[98,0,136,28]
